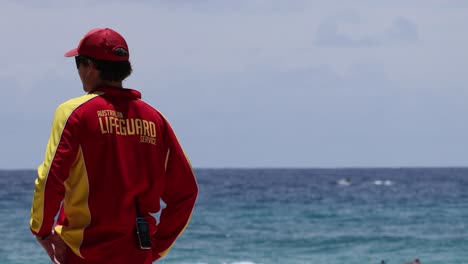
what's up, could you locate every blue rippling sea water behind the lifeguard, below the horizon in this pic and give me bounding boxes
[0,168,468,264]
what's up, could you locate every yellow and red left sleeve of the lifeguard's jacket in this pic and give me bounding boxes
[30,103,78,236]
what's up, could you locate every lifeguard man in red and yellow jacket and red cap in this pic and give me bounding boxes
[30,28,198,263]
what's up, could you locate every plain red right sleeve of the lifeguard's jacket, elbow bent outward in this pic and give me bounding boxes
[152,122,198,261]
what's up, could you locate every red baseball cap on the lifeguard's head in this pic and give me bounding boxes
[65,28,130,61]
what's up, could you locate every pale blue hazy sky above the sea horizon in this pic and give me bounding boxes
[0,0,468,169]
